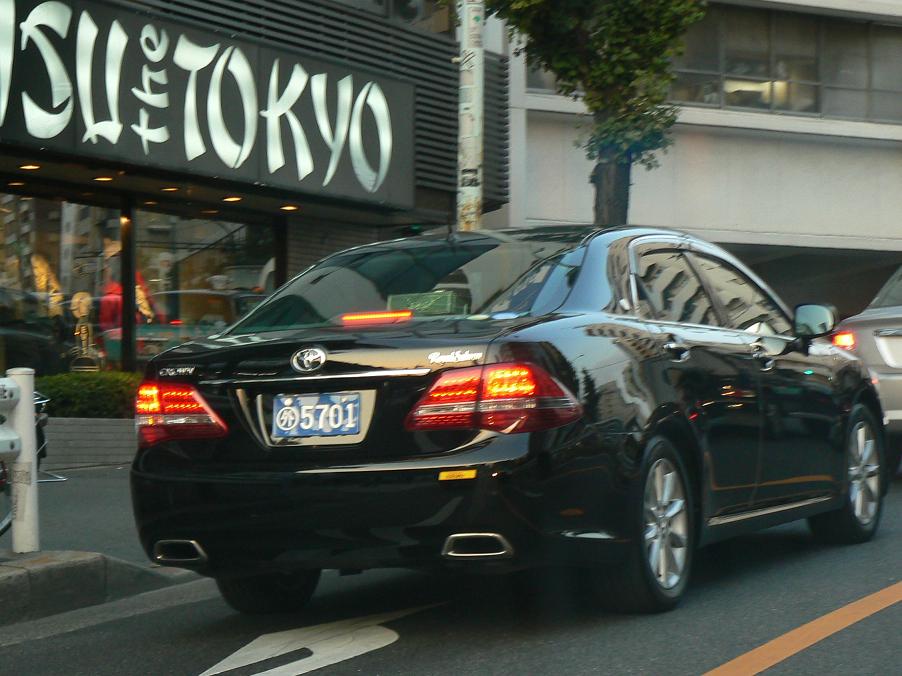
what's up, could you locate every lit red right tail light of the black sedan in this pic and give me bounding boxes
[405,364,582,434]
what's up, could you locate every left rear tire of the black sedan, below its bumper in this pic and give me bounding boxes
[216,570,320,615]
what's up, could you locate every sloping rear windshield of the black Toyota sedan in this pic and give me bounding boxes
[229,237,583,334]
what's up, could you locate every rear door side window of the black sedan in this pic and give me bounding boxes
[639,251,720,326]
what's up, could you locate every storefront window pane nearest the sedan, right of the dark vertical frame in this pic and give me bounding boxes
[135,211,275,364]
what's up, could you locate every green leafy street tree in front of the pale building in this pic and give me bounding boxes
[486,0,707,225]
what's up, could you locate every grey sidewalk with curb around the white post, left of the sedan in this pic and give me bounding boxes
[0,465,197,625]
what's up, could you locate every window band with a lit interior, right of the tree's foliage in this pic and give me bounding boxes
[671,6,902,122]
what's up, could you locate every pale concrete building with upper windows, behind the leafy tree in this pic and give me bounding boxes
[488,0,902,315]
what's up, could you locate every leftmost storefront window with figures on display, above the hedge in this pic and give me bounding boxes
[0,195,121,375]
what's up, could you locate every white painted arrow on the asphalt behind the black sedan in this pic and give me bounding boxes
[201,606,433,676]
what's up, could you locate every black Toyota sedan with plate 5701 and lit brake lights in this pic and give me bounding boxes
[131,228,886,612]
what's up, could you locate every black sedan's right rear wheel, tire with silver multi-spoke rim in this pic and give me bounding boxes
[592,437,696,613]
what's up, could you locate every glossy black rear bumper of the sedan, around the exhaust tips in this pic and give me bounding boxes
[131,448,625,576]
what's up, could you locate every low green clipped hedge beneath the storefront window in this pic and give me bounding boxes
[35,371,141,418]
